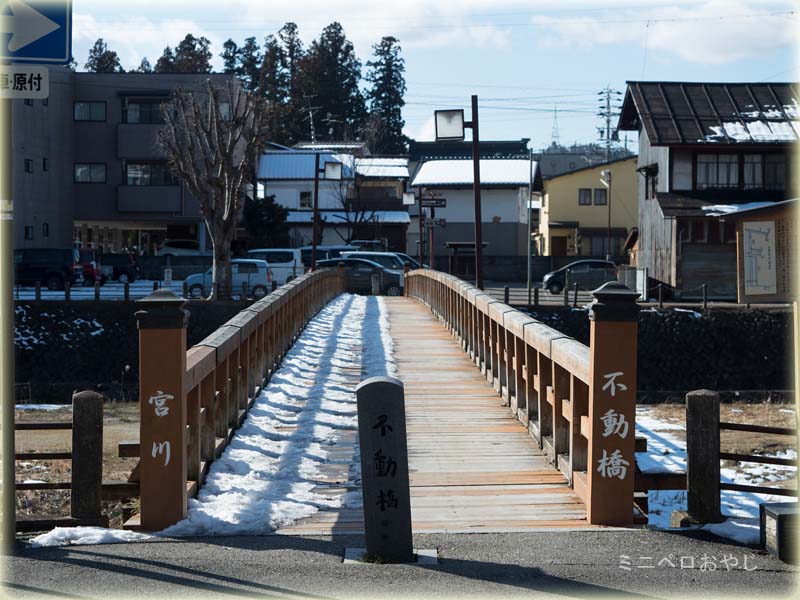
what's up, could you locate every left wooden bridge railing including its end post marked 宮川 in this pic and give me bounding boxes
[129,269,345,531]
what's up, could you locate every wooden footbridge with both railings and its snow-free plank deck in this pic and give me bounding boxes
[125,270,637,535]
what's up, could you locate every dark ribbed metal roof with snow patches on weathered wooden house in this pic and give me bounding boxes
[619,81,800,146]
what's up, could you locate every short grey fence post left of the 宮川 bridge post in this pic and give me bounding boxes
[70,390,108,527]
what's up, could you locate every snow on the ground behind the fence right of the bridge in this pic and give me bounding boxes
[636,406,797,544]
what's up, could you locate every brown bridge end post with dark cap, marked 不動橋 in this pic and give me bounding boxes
[586,281,639,525]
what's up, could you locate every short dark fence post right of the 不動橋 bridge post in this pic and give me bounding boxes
[686,390,723,523]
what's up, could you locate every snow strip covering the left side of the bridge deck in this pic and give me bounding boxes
[31,294,396,546]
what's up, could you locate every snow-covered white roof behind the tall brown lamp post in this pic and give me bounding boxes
[411,159,538,186]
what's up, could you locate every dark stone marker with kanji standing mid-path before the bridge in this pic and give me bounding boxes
[356,377,414,563]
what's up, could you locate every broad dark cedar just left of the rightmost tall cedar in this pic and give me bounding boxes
[300,22,367,140]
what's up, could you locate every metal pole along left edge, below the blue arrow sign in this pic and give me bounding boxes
[0,95,17,555]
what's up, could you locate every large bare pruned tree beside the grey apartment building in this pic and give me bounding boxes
[158,78,267,300]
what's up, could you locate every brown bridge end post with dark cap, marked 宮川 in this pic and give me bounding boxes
[135,289,189,531]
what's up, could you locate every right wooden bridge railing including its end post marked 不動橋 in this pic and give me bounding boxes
[404,269,638,525]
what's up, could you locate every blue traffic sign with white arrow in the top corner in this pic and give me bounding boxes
[0,0,72,65]
